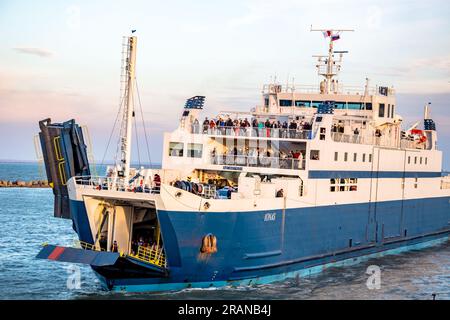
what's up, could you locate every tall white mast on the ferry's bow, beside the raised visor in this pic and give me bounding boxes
[117,36,137,181]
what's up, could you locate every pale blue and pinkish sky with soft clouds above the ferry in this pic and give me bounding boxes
[0,0,450,169]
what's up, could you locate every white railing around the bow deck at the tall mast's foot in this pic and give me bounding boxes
[74,176,160,193]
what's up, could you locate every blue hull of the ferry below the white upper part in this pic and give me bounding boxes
[71,197,450,292]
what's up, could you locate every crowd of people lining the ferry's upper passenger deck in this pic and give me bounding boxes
[192,117,311,138]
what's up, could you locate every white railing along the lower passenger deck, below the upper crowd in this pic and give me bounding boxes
[211,155,306,170]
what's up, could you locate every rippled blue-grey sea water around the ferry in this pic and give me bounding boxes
[0,163,450,299]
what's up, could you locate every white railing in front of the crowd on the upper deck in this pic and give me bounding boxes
[192,125,312,140]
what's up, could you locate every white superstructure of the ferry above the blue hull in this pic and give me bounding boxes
[68,30,450,260]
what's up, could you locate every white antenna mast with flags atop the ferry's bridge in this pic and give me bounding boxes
[310,25,355,94]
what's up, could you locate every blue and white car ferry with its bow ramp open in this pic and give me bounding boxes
[37,30,450,292]
